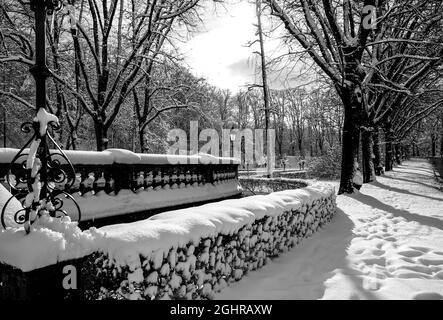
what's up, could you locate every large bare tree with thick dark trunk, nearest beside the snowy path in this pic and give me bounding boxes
[266,0,376,193]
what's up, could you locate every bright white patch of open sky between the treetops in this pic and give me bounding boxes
[180,0,312,92]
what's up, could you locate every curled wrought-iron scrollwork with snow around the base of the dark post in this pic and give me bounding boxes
[0,122,81,233]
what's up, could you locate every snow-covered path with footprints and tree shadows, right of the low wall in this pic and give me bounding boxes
[216,160,443,300]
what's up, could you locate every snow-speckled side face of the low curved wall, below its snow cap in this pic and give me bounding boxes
[82,190,336,299]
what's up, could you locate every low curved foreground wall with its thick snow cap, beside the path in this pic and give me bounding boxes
[0,183,336,300]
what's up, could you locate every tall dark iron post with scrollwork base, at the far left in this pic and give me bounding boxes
[1,0,81,233]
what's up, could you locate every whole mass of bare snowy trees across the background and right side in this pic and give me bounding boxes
[0,0,443,193]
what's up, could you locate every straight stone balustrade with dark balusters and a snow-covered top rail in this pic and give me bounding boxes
[0,148,241,221]
